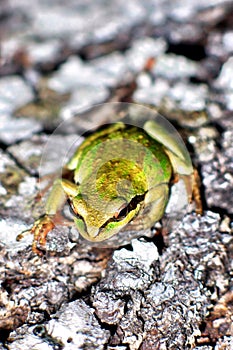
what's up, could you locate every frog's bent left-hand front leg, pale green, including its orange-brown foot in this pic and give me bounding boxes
[16,179,78,255]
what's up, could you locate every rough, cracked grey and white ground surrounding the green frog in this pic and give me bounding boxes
[0,0,233,350]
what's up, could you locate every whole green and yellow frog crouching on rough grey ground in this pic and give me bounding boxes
[17,120,198,255]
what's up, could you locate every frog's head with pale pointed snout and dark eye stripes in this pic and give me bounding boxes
[69,159,147,242]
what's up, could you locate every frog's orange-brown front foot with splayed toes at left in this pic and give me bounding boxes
[16,215,55,255]
